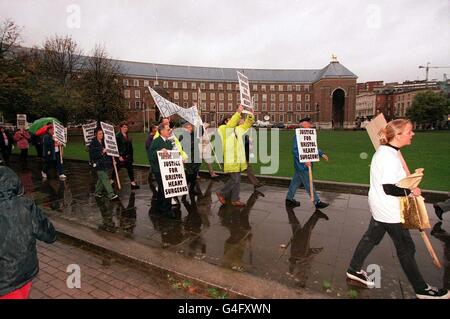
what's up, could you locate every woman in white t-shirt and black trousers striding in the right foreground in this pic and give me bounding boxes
[347,119,450,299]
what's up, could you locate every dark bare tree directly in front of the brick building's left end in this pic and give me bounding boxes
[76,46,126,124]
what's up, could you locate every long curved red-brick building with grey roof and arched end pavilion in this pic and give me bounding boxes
[118,59,357,130]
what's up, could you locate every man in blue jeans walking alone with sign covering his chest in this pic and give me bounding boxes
[286,117,329,209]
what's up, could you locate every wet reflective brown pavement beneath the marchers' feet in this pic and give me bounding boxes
[7,158,450,298]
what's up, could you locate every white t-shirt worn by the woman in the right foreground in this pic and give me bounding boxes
[369,145,406,224]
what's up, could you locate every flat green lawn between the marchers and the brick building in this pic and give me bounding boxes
[18,130,450,191]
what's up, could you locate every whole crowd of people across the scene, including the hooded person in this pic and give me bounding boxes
[0,106,450,299]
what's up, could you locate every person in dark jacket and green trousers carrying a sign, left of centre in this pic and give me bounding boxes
[89,128,118,200]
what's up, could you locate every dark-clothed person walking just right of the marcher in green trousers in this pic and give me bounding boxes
[113,122,139,189]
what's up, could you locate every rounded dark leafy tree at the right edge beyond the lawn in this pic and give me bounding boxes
[406,91,450,127]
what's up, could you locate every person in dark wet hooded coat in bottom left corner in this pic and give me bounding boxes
[0,166,56,299]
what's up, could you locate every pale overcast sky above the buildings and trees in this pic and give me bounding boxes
[0,0,450,82]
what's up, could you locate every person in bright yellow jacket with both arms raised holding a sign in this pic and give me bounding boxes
[216,105,255,207]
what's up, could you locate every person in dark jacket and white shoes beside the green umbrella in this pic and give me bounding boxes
[41,126,67,180]
